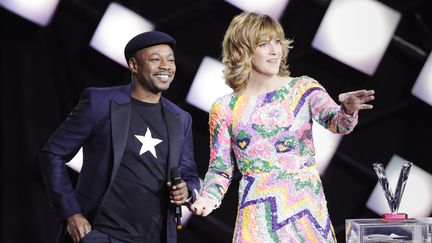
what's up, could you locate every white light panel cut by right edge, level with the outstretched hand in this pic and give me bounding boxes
[411,54,432,105]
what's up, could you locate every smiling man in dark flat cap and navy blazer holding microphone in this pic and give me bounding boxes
[39,31,199,243]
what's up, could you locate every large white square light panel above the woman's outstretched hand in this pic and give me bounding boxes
[312,0,401,75]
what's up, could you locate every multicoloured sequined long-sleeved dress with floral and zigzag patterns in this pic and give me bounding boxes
[201,76,357,243]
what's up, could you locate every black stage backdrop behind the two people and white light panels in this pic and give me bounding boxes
[0,0,432,243]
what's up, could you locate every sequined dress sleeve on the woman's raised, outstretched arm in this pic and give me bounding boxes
[308,78,358,134]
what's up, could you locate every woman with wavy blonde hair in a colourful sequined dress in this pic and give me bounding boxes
[190,13,374,243]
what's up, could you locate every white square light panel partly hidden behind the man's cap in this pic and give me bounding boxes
[90,3,154,67]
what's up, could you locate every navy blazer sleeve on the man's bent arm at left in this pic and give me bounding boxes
[39,89,94,221]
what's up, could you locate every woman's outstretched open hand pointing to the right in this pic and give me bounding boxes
[339,90,375,115]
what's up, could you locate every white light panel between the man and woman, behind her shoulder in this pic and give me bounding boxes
[186,57,233,112]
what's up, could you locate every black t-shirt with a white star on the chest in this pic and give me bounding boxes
[95,99,169,243]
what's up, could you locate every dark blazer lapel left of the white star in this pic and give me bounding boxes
[111,100,130,182]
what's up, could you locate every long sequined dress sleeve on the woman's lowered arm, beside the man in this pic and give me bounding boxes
[201,99,234,208]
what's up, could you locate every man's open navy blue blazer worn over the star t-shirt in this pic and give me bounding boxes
[39,84,200,242]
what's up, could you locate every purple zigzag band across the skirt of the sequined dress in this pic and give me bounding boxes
[240,176,331,238]
